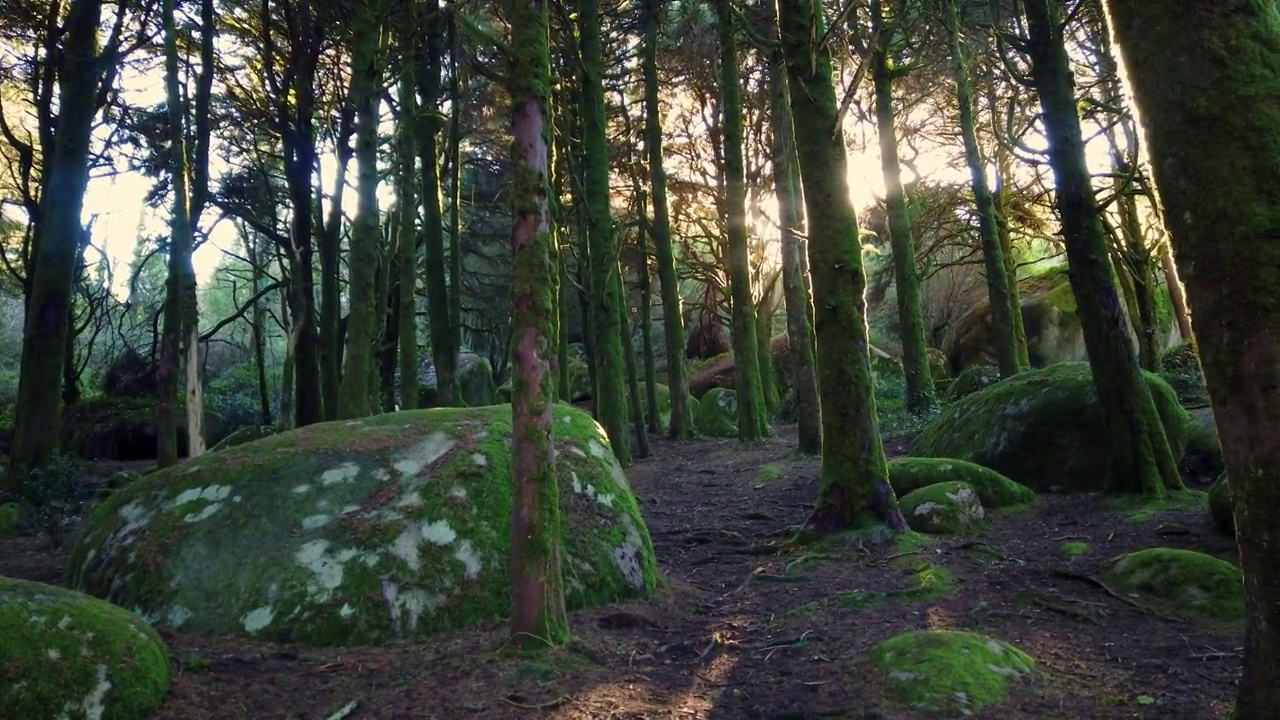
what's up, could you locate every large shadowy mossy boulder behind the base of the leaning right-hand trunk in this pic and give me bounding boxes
[911,363,1190,492]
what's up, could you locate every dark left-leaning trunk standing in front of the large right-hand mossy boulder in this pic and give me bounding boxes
[1023,0,1183,496]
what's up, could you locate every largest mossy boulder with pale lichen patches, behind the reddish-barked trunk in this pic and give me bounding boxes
[68,405,657,646]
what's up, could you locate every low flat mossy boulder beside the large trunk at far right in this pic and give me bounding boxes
[1102,547,1244,621]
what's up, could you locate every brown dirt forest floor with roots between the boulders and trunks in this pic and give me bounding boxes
[0,425,1240,720]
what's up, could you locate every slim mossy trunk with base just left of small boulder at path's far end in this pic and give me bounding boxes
[640,0,694,439]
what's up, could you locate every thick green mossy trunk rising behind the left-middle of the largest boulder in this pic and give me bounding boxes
[337,5,383,419]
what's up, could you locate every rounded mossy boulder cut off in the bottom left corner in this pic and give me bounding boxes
[0,578,169,720]
